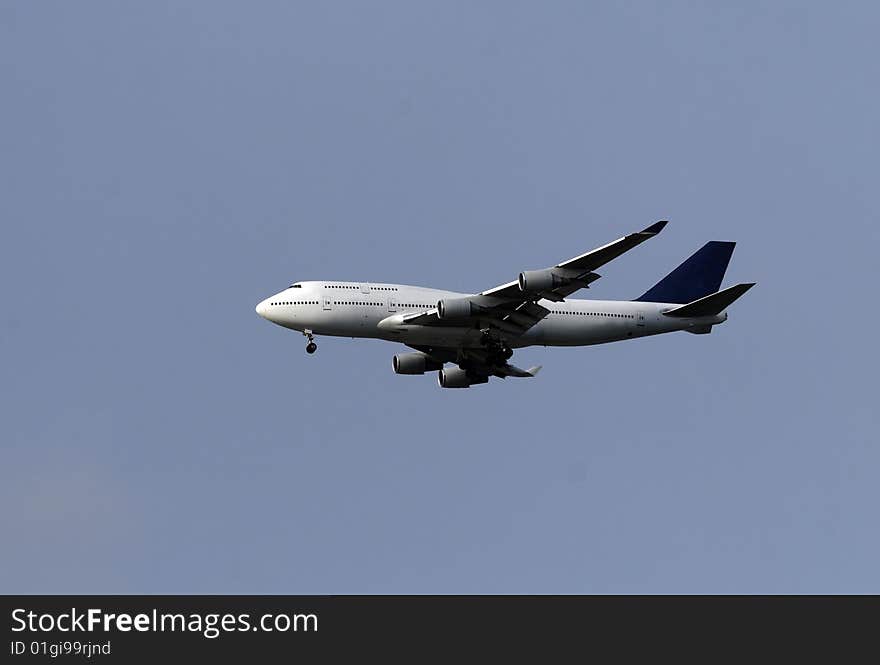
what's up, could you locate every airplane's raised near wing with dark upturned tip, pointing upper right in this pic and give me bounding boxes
[403,220,667,336]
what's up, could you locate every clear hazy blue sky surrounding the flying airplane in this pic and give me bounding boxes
[0,1,880,593]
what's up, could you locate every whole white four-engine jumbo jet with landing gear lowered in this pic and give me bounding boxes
[256,220,755,388]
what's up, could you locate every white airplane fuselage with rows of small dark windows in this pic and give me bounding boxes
[257,281,727,348]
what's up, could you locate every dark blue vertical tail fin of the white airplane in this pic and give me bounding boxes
[636,240,736,304]
